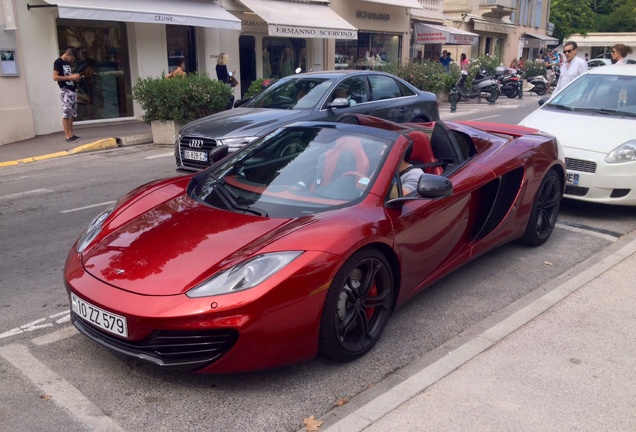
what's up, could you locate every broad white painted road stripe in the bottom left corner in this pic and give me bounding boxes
[0,344,124,432]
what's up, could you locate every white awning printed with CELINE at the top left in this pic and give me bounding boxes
[45,0,241,30]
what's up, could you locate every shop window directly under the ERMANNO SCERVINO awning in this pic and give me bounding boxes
[263,37,309,79]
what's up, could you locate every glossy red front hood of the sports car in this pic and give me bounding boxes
[82,194,307,295]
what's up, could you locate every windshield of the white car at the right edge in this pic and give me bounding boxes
[547,74,636,117]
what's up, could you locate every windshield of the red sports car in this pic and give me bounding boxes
[189,127,392,218]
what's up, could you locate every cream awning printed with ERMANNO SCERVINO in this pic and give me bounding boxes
[239,0,358,39]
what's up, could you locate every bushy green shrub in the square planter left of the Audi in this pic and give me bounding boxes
[132,72,232,124]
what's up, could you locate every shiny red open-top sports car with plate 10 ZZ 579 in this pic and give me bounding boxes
[64,115,565,373]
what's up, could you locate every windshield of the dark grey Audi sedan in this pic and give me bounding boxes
[243,77,334,110]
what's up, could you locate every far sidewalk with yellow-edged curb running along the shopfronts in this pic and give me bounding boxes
[0,96,537,168]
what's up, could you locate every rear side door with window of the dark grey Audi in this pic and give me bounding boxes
[368,74,414,123]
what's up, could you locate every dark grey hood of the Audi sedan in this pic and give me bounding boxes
[180,108,312,138]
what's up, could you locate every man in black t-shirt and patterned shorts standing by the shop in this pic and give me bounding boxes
[53,48,82,142]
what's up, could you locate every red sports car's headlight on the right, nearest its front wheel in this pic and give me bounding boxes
[186,251,302,298]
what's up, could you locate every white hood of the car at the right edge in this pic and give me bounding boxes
[519,108,636,156]
